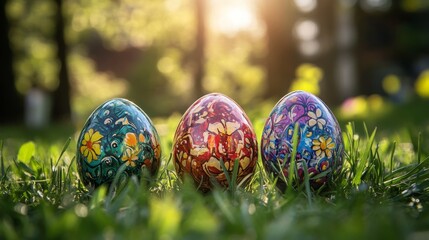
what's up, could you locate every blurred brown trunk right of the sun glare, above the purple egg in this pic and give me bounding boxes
[261,0,297,99]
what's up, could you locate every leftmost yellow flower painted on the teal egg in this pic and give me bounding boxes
[80,128,103,163]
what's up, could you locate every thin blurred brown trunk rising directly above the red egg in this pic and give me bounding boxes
[194,0,206,97]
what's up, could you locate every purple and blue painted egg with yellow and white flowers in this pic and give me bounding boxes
[261,91,344,190]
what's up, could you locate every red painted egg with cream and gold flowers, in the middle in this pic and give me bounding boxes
[173,93,258,192]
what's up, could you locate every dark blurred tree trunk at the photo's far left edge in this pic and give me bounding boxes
[0,1,24,123]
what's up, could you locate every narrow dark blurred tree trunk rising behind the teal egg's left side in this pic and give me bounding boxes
[53,0,71,121]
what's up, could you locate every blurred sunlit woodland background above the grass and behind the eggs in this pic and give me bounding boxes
[0,0,429,131]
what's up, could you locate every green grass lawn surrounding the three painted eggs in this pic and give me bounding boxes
[0,102,429,239]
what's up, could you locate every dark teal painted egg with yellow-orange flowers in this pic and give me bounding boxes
[76,98,161,188]
